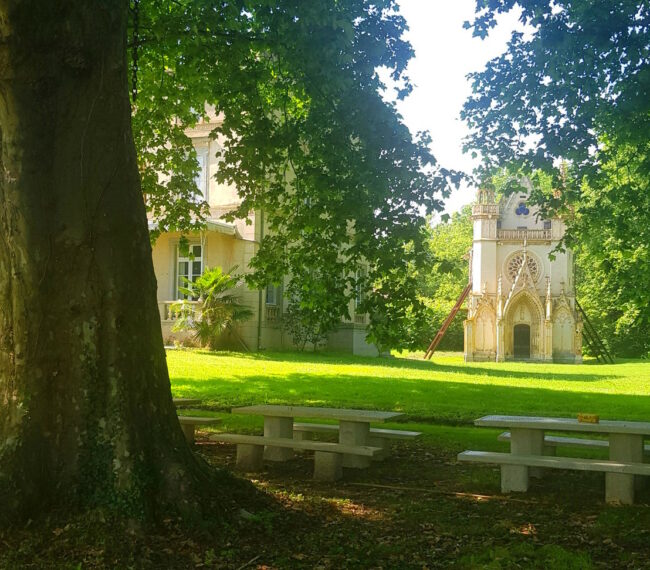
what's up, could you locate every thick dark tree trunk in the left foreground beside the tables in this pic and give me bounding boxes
[0,0,219,520]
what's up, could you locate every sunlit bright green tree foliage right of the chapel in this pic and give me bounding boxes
[572,147,650,356]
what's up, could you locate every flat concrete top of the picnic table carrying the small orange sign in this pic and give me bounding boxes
[474,416,650,436]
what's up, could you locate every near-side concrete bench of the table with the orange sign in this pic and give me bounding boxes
[458,451,650,504]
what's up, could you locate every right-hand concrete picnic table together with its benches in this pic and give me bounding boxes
[459,415,650,504]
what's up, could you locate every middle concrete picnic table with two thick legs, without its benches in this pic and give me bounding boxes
[232,404,404,468]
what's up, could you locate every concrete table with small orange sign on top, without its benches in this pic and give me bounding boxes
[474,415,650,504]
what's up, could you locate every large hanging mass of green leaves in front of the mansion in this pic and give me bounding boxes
[134,0,458,350]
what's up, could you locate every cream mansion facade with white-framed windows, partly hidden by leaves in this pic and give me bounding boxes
[149,115,377,356]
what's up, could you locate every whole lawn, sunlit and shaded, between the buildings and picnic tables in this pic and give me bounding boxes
[168,350,650,423]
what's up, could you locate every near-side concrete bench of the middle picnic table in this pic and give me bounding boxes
[210,433,381,481]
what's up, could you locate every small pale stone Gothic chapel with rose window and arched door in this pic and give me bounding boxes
[464,184,582,363]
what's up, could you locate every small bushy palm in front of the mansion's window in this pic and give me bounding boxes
[172,267,253,349]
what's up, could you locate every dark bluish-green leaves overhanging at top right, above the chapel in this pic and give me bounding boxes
[463,0,650,182]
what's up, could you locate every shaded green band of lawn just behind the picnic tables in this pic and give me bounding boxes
[170,373,648,424]
